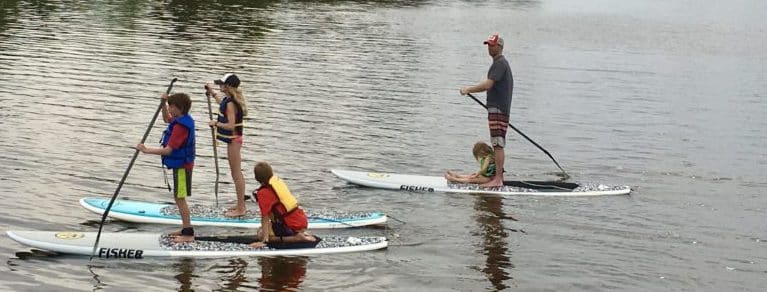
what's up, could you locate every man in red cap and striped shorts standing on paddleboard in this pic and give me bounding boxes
[461,34,514,187]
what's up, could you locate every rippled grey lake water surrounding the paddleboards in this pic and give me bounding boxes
[0,0,767,291]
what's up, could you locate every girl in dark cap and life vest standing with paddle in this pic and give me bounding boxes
[205,73,248,217]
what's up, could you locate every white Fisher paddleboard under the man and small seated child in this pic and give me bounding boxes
[330,169,631,196]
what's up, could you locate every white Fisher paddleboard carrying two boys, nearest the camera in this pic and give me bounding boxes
[6,231,388,259]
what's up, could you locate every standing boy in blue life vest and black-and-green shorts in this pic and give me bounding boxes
[136,93,195,243]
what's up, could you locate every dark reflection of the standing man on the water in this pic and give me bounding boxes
[474,195,514,291]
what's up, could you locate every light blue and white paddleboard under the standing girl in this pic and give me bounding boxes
[80,198,388,229]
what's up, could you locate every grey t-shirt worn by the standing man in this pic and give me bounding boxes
[487,55,514,115]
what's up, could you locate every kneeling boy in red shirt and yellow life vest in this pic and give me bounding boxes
[250,162,317,248]
